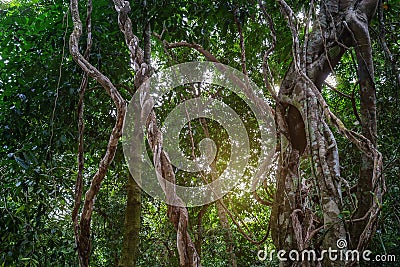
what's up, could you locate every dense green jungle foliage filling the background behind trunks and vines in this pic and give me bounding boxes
[0,0,400,266]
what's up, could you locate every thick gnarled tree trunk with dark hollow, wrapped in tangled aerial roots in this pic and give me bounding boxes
[271,0,382,266]
